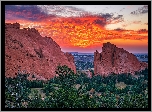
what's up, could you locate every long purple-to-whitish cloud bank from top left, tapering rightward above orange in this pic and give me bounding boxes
[5,5,90,21]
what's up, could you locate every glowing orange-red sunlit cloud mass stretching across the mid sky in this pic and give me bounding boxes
[6,16,148,48]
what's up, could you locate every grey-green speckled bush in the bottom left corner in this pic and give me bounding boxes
[5,74,30,108]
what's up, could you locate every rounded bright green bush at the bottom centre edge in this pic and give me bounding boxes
[44,87,98,108]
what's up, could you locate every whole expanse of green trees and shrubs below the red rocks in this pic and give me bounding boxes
[5,65,148,108]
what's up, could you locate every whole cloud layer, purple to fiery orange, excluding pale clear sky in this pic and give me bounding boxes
[5,5,148,53]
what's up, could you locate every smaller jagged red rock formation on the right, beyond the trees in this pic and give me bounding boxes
[94,42,148,76]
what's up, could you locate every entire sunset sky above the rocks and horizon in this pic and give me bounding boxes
[5,5,148,53]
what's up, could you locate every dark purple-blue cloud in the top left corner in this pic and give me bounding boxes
[5,5,51,21]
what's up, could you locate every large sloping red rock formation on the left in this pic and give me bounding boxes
[5,23,76,79]
